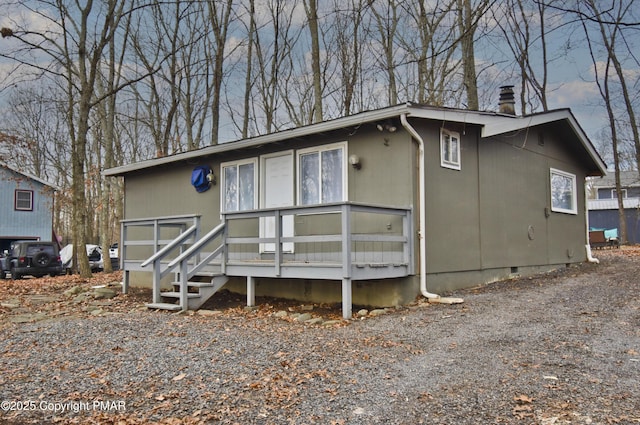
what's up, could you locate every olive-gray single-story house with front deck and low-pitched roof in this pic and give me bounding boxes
[104,96,606,318]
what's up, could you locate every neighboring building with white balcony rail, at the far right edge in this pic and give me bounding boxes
[588,171,640,244]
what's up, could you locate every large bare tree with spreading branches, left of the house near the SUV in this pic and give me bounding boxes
[0,0,156,277]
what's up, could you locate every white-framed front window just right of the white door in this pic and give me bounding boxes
[298,144,347,205]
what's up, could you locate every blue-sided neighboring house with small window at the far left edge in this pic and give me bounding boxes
[0,162,55,252]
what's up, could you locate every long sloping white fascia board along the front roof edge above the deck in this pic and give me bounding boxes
[102,105,407,176]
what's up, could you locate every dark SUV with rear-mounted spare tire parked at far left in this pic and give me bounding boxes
[1,241,62,280]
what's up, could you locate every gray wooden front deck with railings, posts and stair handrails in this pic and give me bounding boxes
[121,202,414,317]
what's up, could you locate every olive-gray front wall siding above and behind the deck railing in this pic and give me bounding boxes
[125,125,416,256]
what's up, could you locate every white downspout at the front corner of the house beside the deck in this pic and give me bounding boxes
[400,114,464,304]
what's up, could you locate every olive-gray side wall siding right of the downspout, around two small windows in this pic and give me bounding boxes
[423,121,586,278]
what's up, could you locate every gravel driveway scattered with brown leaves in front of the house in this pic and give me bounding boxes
[0,248,640,425]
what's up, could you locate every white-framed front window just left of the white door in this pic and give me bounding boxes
[220,159,257,212]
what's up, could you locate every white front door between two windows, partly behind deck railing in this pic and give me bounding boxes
[260,151,294,252]
